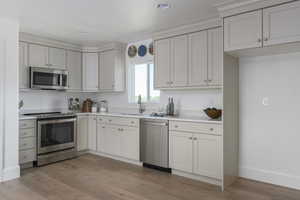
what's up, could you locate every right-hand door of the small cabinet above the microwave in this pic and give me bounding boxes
[48,48,67,69]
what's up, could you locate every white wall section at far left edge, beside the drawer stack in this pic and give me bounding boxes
[0,19,20,181]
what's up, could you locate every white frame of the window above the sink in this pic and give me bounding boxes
[128,60,159,104]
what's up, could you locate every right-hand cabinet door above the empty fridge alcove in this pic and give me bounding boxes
[263,1,300,46]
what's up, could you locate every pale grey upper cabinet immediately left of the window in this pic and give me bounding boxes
[99,50,125,92]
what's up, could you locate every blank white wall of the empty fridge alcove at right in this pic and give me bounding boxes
[240,53,300,189]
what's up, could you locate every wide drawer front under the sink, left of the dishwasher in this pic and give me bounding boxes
[98,116,140,127]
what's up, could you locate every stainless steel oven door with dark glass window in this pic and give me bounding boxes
[38,118,76,154]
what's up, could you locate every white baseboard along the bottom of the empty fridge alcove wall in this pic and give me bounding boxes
[239,167,300,190]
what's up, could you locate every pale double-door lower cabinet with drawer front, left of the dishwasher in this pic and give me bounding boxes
[97,116,140,161]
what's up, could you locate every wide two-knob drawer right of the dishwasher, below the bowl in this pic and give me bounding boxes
[169,121,222,135]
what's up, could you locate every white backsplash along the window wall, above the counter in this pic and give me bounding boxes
[91,89,223,116]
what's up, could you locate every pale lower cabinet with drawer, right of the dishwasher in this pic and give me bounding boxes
[169,122,222,180]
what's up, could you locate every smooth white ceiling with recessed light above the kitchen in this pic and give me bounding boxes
[0,0,245,46]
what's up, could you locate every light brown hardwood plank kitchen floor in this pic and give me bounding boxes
[0,155,300,200]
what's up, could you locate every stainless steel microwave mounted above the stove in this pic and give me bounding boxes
[29,67,68,90]
